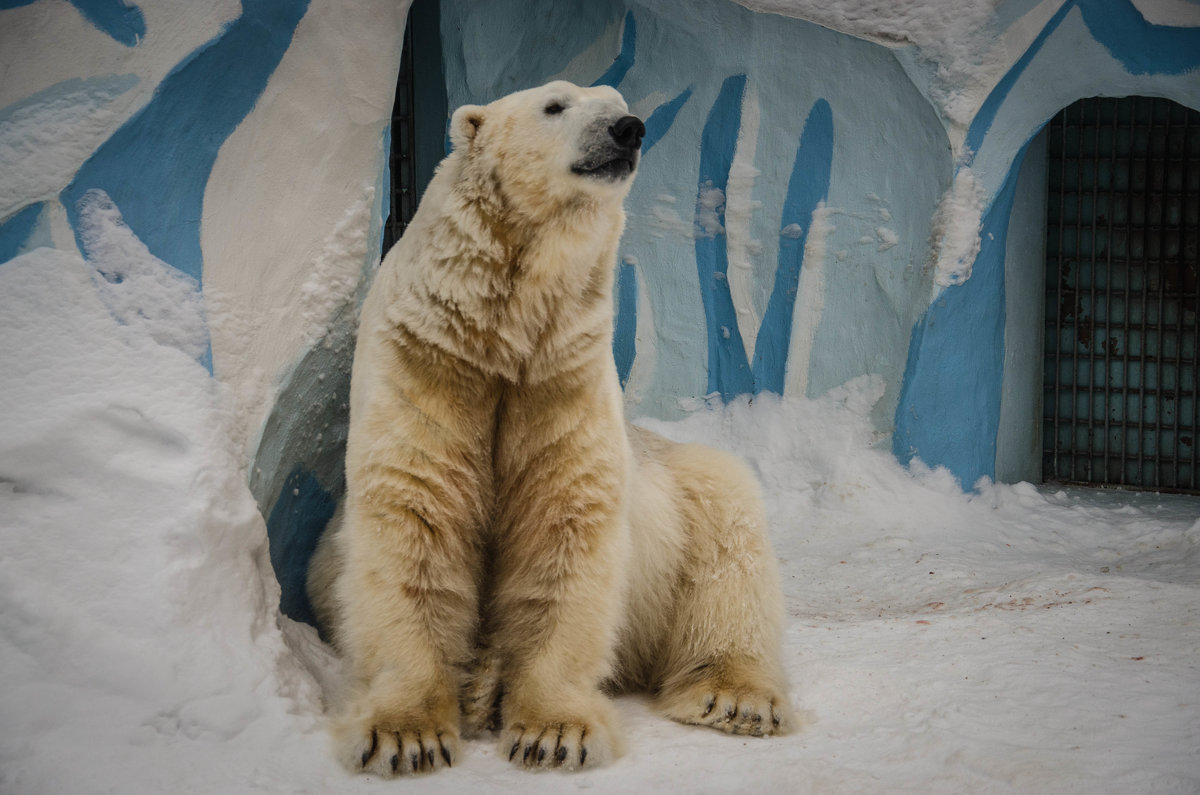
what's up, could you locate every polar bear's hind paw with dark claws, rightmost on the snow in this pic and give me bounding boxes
[659,680,796,737]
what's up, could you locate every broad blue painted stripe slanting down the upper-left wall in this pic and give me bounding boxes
[61,0,308,287]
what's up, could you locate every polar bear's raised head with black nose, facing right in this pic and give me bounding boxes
[450,80,646,214]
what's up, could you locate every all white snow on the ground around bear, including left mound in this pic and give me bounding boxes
[0,244,1200,794]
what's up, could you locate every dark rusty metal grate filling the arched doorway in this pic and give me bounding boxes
[1043,96,1200,492]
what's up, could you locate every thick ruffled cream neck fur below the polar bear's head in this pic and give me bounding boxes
[392,187,624,382]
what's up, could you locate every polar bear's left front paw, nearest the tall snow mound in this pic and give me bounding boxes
[334,715,458,777]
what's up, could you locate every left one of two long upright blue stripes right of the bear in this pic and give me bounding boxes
[696,74,754,401]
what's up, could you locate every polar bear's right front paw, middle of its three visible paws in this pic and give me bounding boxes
[500,694,620,770]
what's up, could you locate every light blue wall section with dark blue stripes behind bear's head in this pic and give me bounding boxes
[442,0,953,422]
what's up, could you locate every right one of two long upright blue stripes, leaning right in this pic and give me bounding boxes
[754,100,833,395]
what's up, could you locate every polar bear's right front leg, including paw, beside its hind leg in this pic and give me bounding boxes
[491,377,629,769]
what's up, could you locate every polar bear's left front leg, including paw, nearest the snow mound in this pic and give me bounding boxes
[332,391,491,776]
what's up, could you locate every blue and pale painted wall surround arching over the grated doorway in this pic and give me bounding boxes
[893,0,1200,486]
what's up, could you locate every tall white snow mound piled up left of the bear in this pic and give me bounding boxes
[0,249,325,793]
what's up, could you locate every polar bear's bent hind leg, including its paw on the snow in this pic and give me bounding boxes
[656,446,794,736]
